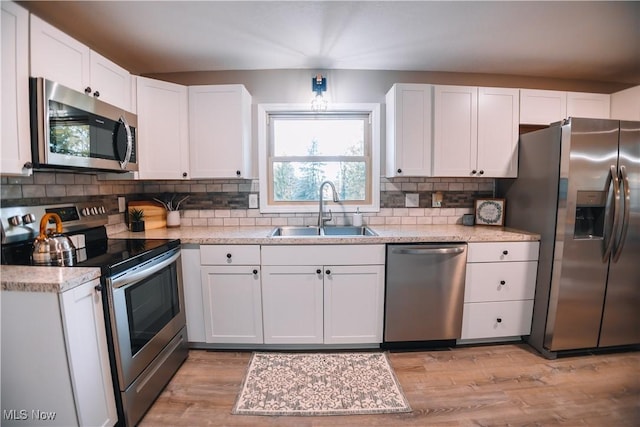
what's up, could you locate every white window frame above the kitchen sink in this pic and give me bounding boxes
[258,103,380,214]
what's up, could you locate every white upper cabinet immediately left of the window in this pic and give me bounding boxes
[189,85,252,178]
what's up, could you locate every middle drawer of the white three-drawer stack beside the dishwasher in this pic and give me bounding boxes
[464,261,538,302]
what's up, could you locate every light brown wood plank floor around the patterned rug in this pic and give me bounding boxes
[140,344,640,427]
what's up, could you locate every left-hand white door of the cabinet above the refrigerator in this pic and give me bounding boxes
[520,89,567,125]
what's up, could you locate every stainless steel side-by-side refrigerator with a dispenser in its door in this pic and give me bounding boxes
[497,118,640,358]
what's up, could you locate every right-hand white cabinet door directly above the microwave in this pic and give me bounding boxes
[90,51,131,111]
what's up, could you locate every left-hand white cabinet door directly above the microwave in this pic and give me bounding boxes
[31,15,91,92]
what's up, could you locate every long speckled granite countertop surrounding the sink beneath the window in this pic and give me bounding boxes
[110,225,540,245]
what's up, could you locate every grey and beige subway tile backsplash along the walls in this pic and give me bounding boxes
[0,172,495,233]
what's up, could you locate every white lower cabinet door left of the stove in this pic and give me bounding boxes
[60,280,118,426]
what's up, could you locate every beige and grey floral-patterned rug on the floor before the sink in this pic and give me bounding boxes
[232,352,411,416]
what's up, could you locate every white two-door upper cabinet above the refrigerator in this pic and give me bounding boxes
[520,89,610,125]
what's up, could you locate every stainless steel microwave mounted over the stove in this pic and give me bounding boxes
[29,78,138,172]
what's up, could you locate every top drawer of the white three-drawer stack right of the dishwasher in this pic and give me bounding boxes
[467,242,540,262]
